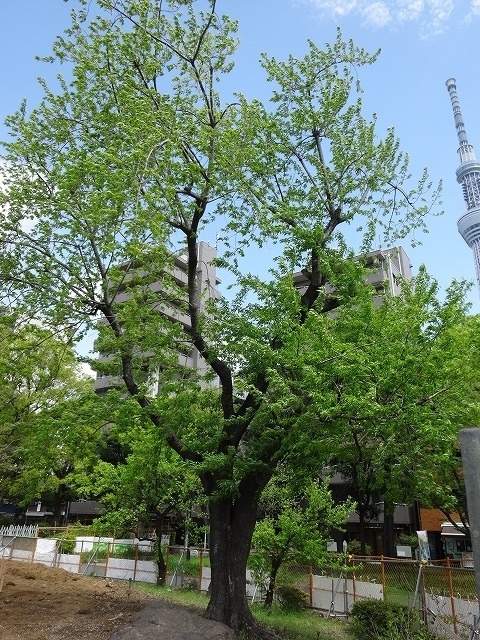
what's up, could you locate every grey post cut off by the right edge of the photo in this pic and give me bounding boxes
[459,428,480,603]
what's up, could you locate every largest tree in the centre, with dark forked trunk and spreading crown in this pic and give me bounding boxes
[0,0,437,638]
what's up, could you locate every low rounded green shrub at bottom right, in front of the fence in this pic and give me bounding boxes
[350,600,428,640]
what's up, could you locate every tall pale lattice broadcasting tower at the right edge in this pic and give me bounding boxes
[445,78,480,288]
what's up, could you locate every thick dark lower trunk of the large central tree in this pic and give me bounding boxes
[205,492,277,640]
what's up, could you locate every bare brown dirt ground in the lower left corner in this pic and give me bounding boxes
[0,560,152,640]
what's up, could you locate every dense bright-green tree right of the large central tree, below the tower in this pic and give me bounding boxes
[295,270,479,557]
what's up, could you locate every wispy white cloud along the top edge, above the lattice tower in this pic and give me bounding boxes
[310,0,462,35]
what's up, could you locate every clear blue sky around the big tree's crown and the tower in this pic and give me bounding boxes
[0,0,480,313]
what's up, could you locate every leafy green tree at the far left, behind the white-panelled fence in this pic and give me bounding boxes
[0,311,101,523]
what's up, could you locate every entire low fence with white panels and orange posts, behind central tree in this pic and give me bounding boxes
[0,527,479,640]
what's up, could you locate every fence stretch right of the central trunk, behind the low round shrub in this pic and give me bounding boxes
[278,556,479,640]
